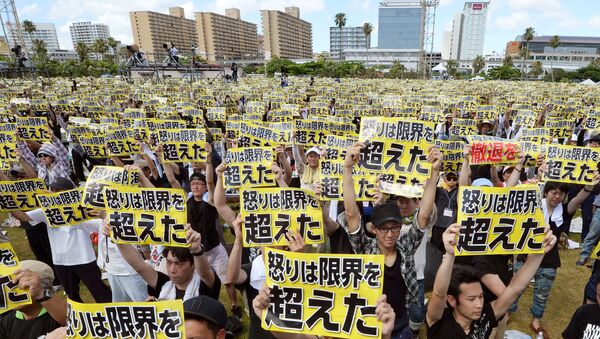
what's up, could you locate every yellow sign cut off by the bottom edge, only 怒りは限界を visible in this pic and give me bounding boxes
[67,300,186,339]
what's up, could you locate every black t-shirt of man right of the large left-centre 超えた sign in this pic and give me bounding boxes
[187,197,221,251]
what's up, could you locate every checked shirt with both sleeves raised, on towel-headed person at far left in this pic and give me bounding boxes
[17,137,71,185]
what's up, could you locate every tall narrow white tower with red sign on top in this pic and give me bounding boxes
[459,1,489,60]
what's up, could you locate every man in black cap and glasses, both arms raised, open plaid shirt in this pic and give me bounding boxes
[338,142,441,338]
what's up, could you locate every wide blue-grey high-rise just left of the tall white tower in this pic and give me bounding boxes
[377,0,426,49]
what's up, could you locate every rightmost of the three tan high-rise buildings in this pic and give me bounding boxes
[260,7,312,60]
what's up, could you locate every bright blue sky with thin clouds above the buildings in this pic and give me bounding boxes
[15,0,600,54]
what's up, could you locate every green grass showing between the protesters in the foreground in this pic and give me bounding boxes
[0,216,591,338]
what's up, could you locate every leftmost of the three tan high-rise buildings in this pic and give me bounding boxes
[129,7,198,62]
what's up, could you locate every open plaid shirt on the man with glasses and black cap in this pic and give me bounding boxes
[338,210,425,305]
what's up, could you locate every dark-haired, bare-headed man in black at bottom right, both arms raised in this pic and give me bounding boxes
[426,224,556,339]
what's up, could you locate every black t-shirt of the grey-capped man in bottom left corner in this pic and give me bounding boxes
[0,310,61,339]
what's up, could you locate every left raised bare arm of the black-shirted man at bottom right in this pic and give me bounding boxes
[426,224,459,327]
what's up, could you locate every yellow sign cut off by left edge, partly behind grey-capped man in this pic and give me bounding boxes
[0,242,31,314]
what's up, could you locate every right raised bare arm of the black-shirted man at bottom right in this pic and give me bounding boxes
[492,226,556,318]
